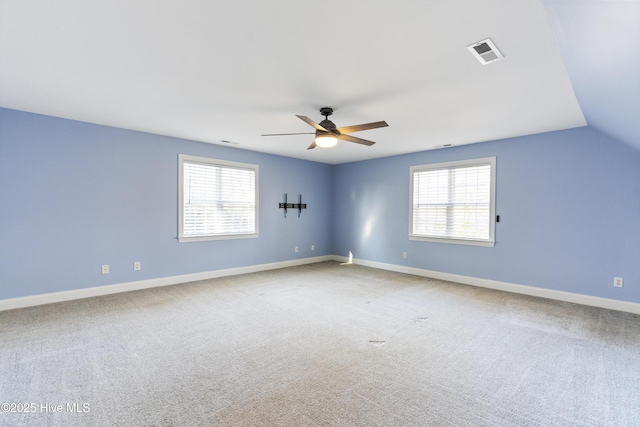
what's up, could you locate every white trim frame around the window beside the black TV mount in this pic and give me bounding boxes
[178,154,260,243]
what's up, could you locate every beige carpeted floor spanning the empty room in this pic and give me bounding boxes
[0,262,640,427]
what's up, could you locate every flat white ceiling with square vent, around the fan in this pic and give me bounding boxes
[0,0,586,164]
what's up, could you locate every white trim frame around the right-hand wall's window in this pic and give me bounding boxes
[409,157,496,247]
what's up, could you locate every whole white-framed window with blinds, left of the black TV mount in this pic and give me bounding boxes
[178,154,258,242]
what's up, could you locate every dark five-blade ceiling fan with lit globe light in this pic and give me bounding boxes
[262,107,389,150]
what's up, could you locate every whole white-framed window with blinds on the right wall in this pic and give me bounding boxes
[409,157,496,246]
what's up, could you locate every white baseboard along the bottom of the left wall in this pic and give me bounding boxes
[0,256,333,311]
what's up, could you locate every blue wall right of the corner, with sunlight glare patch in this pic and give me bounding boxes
[332,128,640,302]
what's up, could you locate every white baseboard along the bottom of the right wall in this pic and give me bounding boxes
[331,255,640,314]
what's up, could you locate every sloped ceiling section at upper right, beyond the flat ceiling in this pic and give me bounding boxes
[544,0,640,154]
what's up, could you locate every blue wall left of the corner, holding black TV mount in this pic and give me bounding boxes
[0,109,332,299]
